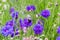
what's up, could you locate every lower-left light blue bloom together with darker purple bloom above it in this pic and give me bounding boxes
[1,20,15,36]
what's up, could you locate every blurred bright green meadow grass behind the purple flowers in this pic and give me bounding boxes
[0,0,60,40]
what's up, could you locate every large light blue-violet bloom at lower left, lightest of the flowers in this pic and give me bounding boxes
[1,21,14,36]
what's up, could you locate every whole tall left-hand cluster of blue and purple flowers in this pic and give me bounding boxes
[1,7,19,37]
